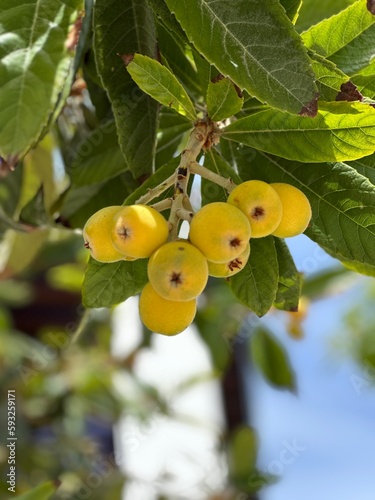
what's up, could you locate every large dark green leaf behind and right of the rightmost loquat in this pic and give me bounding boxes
[239,153,375,275]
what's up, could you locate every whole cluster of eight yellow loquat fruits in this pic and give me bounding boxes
[83,180,311,335]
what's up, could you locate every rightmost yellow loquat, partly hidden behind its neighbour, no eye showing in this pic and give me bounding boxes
[271,182,311,238]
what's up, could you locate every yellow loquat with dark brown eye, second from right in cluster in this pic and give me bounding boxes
[228,180,282,238]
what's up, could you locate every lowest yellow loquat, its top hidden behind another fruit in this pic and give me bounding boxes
[139,283,197,335]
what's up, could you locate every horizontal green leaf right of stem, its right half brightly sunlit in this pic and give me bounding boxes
[223,102,375,162]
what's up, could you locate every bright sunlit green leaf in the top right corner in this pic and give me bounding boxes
[301,0,375,74]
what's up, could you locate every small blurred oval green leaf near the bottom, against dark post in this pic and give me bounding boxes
[228,425,259,481]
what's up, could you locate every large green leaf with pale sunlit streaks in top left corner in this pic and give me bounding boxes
[0,0,82,164]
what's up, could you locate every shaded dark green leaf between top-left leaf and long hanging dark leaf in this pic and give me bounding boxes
[71,120,127,187]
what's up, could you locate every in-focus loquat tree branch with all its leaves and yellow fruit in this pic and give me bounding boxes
[0,0,375,493]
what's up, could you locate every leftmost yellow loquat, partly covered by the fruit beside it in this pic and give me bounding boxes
[83,205,124,262]
